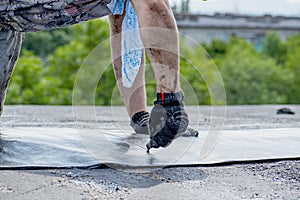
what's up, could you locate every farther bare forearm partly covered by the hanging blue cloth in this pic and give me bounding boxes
[109,11,146,117]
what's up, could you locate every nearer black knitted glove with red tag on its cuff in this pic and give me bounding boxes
[147,92,189,152]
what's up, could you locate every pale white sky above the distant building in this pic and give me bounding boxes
[169,0,300,17]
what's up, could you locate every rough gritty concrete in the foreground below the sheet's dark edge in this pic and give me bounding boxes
[0,161,300,200]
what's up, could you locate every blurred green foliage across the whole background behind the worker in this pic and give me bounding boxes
[6,20,300,105]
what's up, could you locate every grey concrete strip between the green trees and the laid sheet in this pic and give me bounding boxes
[0,105,300,131]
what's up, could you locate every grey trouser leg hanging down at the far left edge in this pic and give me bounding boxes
[0,27,23,115]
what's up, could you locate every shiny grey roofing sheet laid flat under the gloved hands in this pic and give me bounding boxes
[0,127,300,168]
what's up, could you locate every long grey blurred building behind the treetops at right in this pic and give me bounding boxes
[175,13,300,49]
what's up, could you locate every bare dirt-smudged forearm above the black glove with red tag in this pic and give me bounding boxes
[131,0,181,93]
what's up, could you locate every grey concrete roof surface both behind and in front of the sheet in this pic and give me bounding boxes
[0,105,300,200]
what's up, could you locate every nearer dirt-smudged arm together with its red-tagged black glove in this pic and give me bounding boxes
[131,0,189,149]
